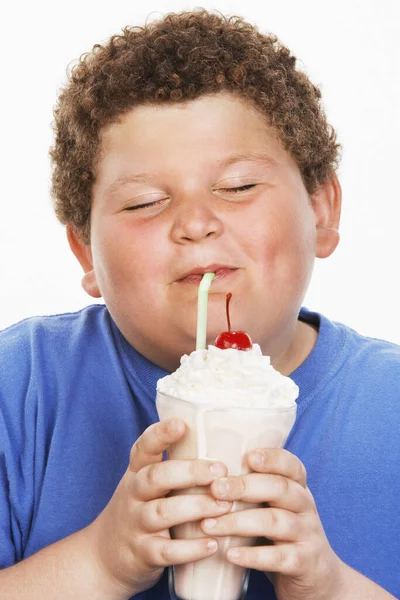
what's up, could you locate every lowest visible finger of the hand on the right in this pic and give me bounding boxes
[226,544,308,577]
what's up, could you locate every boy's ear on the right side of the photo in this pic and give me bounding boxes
[311,175,342,258]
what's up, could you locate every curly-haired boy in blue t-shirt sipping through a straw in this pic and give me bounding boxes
[0,11,400,600]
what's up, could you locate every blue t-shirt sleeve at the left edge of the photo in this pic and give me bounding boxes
[0,326,35,568]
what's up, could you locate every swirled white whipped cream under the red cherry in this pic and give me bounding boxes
[157,344,299,408]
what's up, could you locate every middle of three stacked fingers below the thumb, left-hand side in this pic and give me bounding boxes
[140,494,232,533]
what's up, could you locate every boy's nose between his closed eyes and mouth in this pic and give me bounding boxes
[171,194,224,244]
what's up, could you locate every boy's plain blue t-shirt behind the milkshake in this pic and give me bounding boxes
[0,305,400,600]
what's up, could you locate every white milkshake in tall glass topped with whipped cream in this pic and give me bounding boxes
[157,344,299,600]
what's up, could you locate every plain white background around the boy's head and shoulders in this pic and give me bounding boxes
[0,0,400,343]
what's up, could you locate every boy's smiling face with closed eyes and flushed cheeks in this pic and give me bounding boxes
[71,94,338,370]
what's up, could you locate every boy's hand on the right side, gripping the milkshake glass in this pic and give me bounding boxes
[202,449,345,600]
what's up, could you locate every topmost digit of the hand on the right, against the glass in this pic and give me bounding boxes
[247,448,307,488]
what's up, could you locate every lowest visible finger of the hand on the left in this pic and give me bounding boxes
[140,536,222,567]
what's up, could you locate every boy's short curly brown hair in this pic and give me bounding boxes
[50,9,340,243]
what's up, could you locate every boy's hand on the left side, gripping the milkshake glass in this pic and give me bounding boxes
[88,419,232,598]
